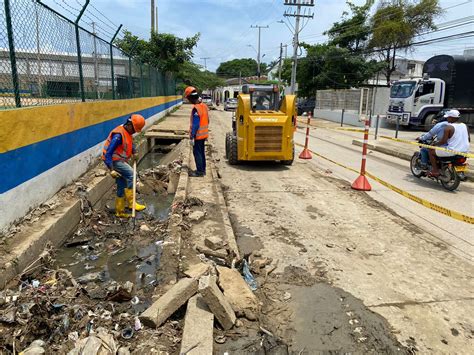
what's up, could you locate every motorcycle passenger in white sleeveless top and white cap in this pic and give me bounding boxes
[429,110,471,177]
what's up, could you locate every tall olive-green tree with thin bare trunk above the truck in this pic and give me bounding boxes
[368,0,442,85]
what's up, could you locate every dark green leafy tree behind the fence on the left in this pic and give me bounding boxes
[115,31,200,72]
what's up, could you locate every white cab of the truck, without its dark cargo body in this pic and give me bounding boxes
[387,76,446,128]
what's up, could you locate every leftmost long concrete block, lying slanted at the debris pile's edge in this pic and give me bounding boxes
[139,278,198,328]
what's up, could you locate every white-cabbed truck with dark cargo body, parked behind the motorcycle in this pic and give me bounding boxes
[386,55,474,130]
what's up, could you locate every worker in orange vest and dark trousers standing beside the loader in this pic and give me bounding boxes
[184,86,209,177]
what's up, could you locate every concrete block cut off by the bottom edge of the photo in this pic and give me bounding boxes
[179,295,214,355]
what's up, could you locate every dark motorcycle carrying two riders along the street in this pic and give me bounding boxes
[410,140,467,191]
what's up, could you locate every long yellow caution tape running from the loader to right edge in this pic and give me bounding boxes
[296,143,474,224]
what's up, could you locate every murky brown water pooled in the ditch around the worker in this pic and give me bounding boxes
[55,152,174,288]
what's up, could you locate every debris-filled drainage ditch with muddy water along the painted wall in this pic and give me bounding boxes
[0,145,188,354]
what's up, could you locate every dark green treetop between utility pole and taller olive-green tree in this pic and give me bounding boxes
[324,0,375,52]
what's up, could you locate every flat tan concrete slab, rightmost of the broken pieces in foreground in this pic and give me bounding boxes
[217,266,260,320]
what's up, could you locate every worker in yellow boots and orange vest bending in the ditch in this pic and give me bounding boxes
[102,114,146,217]
